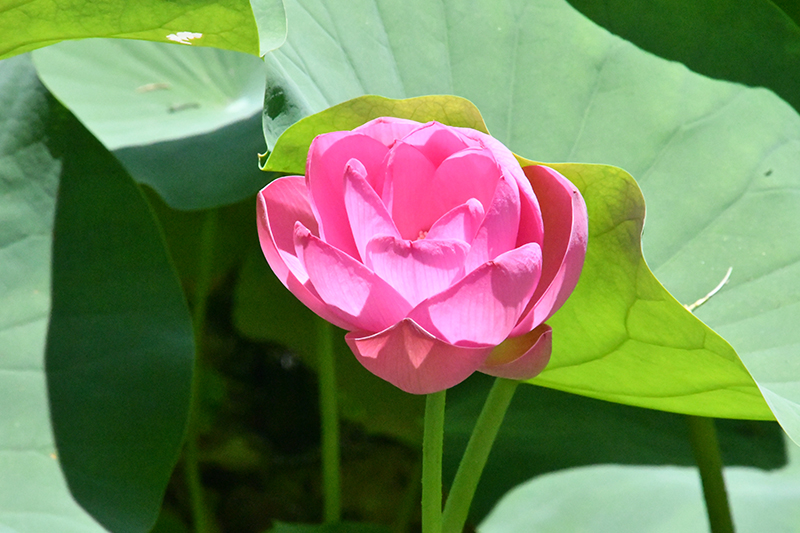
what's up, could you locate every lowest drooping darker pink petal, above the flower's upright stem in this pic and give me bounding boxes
[345,318,493,394]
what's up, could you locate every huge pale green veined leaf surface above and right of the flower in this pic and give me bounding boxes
[260,0,800,432]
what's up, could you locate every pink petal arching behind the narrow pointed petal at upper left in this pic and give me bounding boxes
[306,131,389,257]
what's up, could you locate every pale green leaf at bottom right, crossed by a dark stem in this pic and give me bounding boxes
[478,436,800,533]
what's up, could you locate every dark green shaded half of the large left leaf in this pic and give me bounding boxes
[46,86,194,532]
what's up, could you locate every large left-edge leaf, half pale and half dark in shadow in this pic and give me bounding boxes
[0,57,193,533]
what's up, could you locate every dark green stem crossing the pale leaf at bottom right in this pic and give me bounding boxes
[686,416,734,533]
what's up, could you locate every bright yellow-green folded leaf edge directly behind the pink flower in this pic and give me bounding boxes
[265,96,772,419]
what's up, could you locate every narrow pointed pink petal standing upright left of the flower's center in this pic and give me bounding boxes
[344,159,400,261]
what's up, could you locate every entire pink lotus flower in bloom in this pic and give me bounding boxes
[258,118,588,394]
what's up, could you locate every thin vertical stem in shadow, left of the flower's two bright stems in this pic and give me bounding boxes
[317,319,342,523]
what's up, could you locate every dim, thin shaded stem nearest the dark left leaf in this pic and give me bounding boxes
[183,209,217,533]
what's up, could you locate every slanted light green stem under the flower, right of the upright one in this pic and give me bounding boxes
[442,378,519,533]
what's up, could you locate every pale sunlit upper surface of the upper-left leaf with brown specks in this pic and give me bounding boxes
[33,39,264,150]
